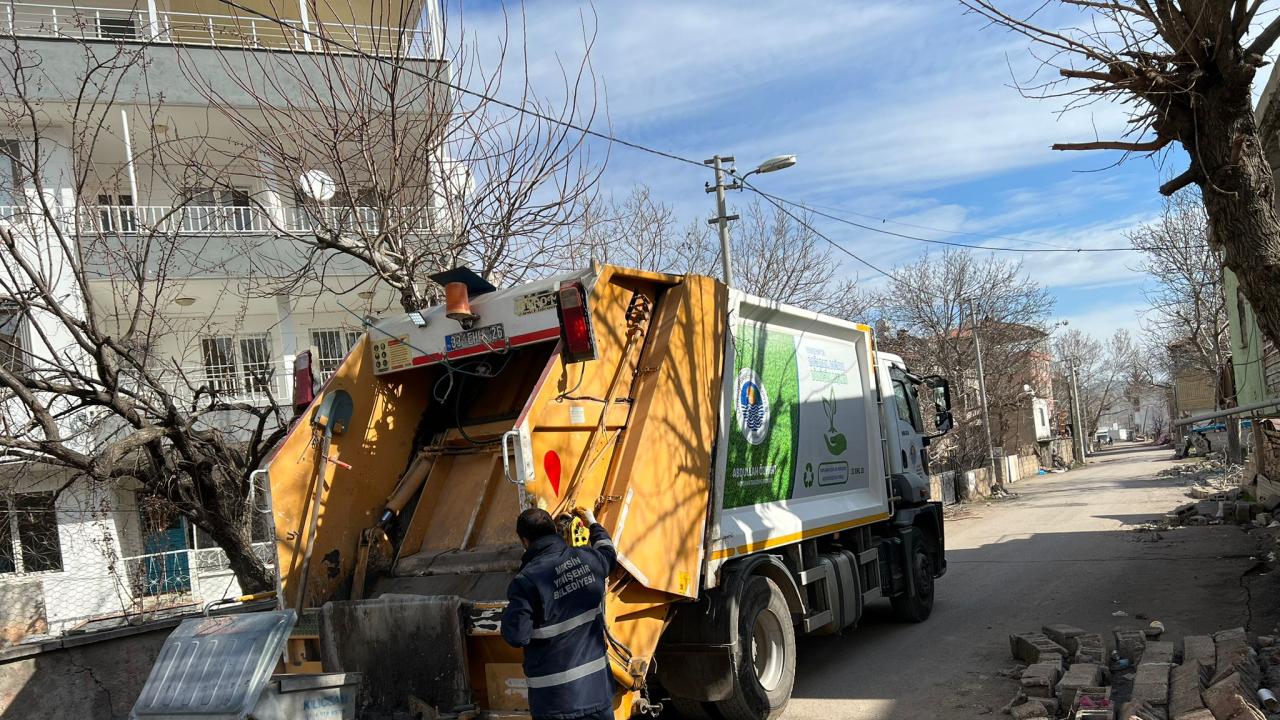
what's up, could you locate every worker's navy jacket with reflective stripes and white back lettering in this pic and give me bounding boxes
[502,523,618,720]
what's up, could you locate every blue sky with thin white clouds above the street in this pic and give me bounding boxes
[451,0,1265,337]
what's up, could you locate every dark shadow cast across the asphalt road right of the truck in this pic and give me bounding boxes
[786,514,1259,720]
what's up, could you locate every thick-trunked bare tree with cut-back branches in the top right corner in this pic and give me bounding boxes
[960,0,1280,353]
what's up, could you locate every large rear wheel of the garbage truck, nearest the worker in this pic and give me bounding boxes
[716,575,796,720]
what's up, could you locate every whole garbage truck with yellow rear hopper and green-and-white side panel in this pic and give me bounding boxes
[266,265,951,720]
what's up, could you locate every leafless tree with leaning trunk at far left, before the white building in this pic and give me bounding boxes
[0,38,288,592]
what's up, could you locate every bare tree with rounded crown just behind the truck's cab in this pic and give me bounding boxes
[877,250,1053,469]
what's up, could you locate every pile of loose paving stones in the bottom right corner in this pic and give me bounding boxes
[1005,623,1280,720]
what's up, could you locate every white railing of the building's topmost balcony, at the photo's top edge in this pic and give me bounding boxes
[0,3,425,56]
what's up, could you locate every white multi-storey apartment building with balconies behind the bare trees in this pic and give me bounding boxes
[0,0,443,644]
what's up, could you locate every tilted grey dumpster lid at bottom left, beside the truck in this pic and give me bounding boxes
[131,610,297,720]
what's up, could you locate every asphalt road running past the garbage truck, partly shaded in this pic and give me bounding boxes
[783,448,1280,720]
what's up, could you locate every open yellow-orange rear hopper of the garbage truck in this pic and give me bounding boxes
[268,265,728,717]
